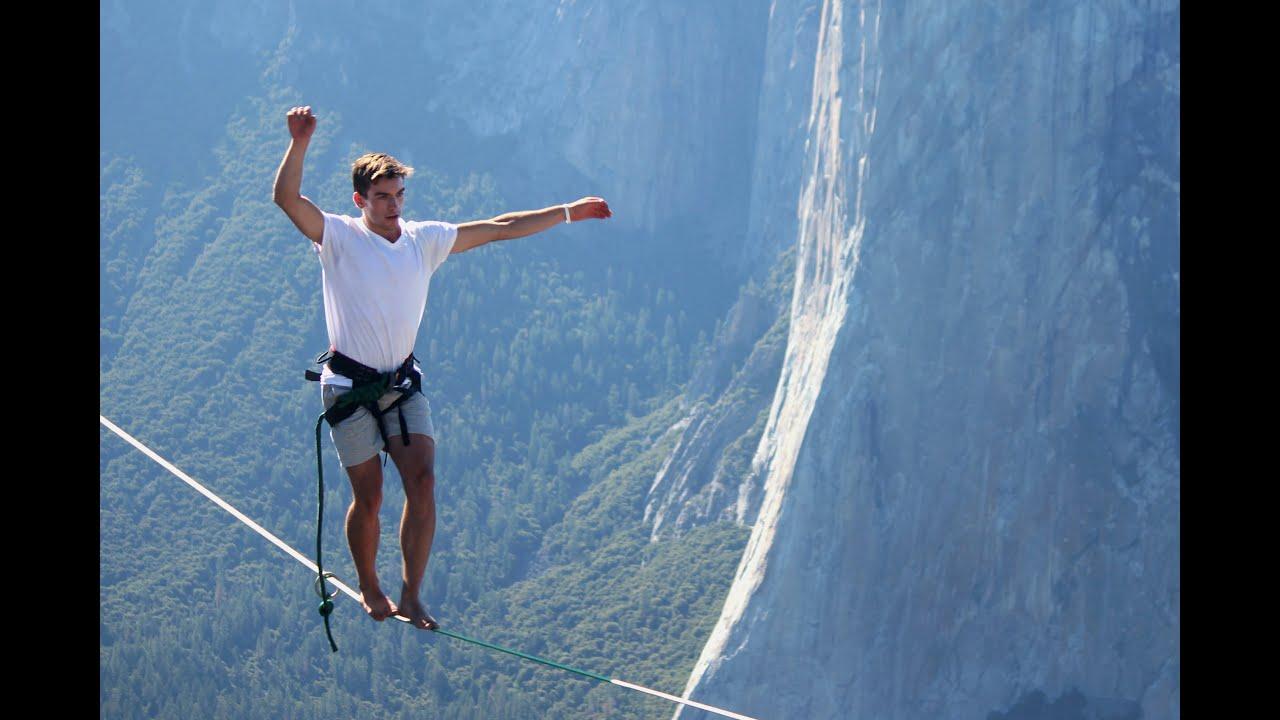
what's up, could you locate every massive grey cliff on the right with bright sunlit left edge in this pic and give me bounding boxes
[677,1,1180,719]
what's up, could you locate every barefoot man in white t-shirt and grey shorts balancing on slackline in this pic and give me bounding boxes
[274,106,613,629]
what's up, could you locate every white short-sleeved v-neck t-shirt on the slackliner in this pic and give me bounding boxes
[311,213,458,387]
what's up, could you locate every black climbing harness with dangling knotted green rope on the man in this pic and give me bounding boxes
[303,347,422,652]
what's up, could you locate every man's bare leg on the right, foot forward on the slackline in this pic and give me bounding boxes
[388,433,439,630]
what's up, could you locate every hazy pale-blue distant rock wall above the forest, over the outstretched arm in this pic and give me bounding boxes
[414,0,768,240]
